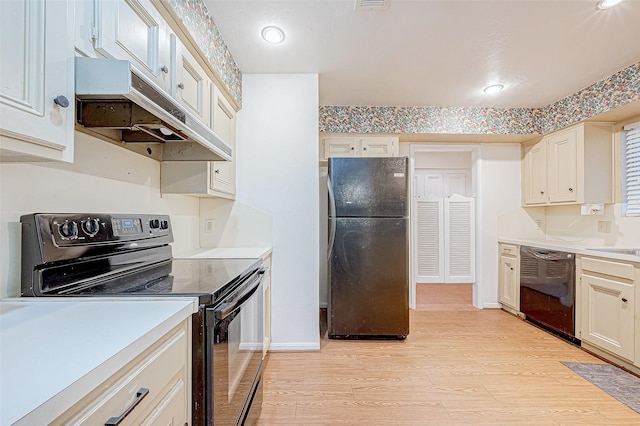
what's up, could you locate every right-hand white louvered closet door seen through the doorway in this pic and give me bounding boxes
[444,195,476,283]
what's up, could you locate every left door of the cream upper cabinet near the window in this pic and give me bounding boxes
[522,140,547,204]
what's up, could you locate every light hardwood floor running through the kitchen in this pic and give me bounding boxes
[260,284,640,425]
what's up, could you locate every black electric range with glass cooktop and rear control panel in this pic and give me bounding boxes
[20,213,264,426]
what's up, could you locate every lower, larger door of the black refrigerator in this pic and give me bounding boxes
[327,218,409,339]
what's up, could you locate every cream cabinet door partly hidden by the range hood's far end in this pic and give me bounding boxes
[210,84,236,194]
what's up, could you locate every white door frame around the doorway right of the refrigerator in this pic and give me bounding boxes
[409,142,482,309]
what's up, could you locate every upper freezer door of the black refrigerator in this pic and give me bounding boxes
[328,157,408,217]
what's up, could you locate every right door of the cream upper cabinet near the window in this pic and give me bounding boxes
[547,129,578,203]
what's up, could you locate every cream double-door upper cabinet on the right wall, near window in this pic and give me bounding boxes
[522,123,613,206]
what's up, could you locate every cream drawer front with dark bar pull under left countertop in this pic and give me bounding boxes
[51,322,189,426]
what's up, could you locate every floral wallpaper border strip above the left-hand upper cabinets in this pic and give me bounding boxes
[167,0,242,107]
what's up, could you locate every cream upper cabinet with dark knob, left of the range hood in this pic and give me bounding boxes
[0,0,75,162]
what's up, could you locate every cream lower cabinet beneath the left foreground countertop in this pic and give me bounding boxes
[50,319,191,426]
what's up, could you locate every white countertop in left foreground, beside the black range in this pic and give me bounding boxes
[0,298,198,425]
